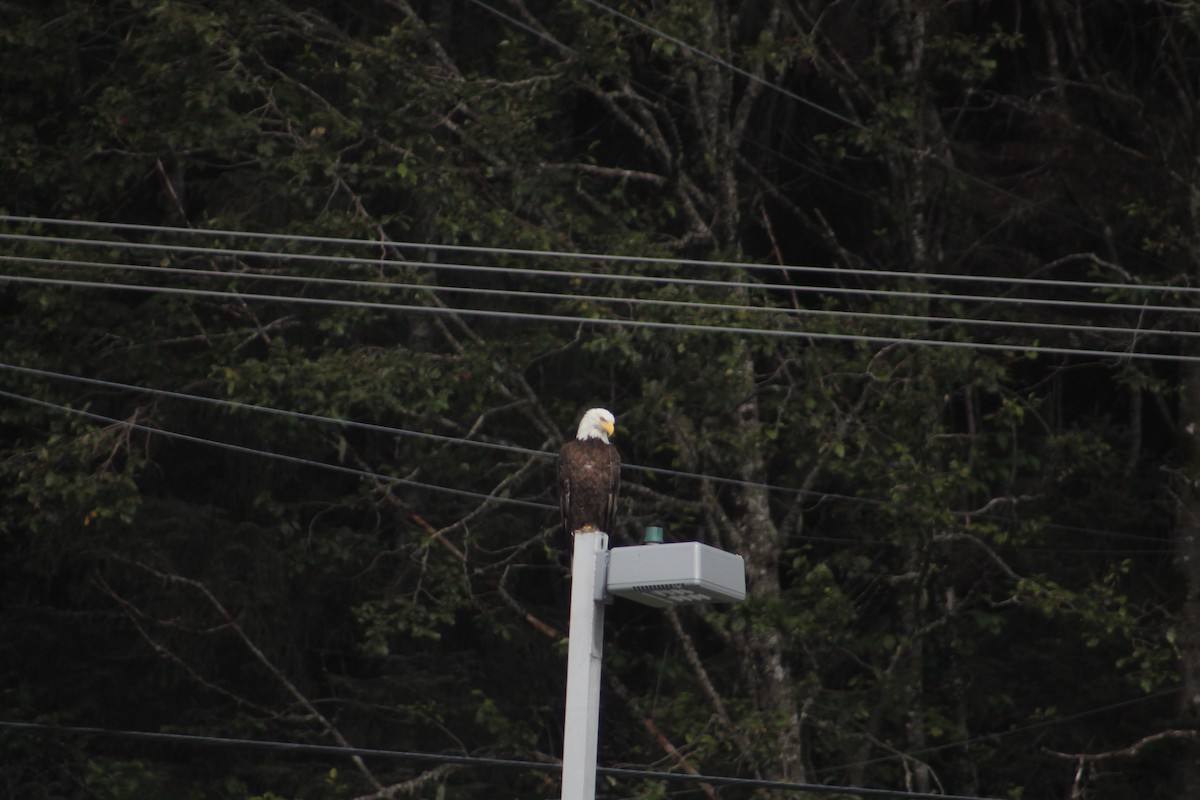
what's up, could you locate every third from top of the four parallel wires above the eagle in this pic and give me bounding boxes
[9,253,1200,338]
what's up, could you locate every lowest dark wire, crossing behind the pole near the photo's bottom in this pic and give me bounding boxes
[0,720,1012,800]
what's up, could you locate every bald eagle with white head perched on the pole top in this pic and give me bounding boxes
[558,408,620,535]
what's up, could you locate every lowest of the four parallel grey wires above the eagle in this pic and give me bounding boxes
[7,275,1200,362]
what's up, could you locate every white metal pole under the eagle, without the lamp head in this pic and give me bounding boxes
[563,531,608,800]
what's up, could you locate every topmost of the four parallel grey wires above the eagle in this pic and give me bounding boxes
[0,215,1200,295]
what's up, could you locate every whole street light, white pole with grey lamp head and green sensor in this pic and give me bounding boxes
[563,528,746,800]
